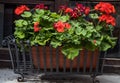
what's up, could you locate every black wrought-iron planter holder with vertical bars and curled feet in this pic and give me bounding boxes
[5,35,106,83]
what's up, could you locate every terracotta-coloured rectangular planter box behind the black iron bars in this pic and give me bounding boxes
[32,46,99,69]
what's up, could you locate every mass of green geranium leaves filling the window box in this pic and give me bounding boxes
[14,4,116,60]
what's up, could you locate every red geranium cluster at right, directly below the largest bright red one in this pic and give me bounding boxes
[99,14,115,26]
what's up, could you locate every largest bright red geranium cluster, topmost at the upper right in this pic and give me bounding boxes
[95,2,115,14]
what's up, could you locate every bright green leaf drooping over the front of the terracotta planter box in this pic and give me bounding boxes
[62,47,79,60]
